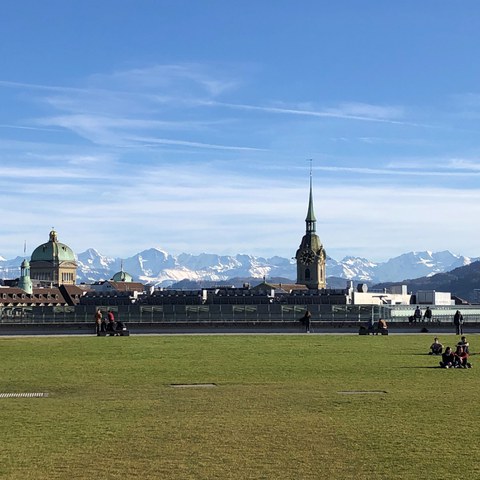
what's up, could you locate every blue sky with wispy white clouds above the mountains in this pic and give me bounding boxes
[0,0,480,261]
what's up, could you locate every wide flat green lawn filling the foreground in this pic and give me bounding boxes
[0,335,480,480]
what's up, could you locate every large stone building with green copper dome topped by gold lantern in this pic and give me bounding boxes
[30,230,77,286]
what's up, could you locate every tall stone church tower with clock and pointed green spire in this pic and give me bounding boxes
[295,170,327,290]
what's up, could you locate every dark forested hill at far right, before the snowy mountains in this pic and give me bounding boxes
[372,261,480,302]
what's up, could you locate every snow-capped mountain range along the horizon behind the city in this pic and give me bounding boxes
[0,248,480,286]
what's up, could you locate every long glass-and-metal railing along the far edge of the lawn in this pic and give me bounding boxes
[0,304,480,324]
